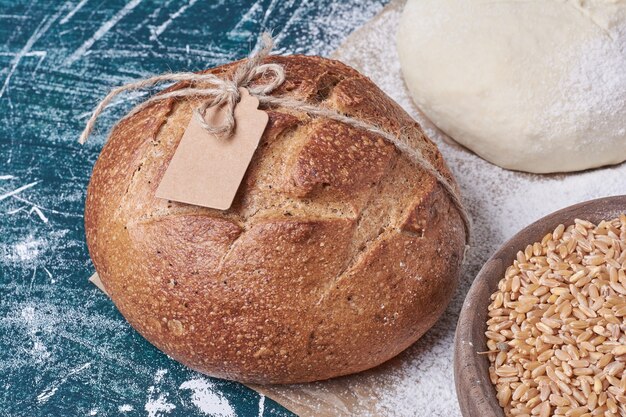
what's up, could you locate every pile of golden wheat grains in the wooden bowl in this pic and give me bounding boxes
[485,215,626,417]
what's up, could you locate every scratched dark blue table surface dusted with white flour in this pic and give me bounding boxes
[0,0,384,417]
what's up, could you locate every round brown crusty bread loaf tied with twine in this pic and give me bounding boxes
[85,56,465,383]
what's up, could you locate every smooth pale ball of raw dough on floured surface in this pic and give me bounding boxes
[397,0,626,173]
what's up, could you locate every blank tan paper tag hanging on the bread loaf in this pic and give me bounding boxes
[156,88,269,210]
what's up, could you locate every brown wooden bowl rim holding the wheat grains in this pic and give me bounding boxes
[454,195,626,417]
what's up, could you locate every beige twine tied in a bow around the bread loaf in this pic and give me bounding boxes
[78,32,471,243]
